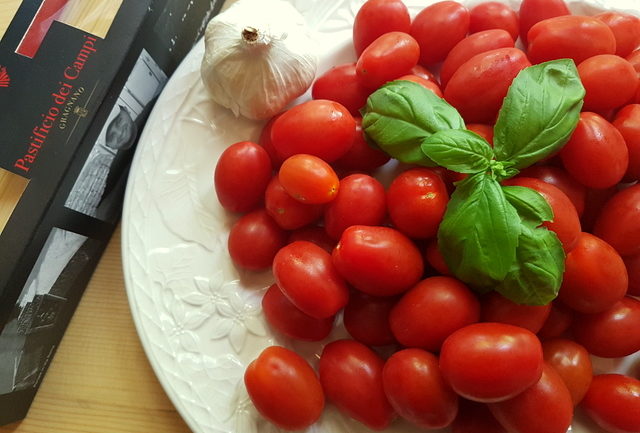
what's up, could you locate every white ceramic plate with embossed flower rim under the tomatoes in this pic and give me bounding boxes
[122,0,639,433]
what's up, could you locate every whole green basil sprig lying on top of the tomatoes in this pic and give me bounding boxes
[362,59,585,305]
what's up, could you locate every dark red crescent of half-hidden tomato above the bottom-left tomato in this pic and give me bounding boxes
[262,284,334,341]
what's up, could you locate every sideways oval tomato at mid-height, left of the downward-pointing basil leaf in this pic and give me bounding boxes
[333,225,424,296]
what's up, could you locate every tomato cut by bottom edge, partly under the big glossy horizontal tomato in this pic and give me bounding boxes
[489,363,573,433]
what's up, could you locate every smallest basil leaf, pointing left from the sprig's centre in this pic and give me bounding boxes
[421,129,493,173]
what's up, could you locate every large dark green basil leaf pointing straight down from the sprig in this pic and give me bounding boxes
[438,173,520,288]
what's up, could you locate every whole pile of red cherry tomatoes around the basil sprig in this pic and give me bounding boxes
[214,0,640,433]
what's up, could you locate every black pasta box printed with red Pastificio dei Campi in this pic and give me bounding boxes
[0,0,222,425]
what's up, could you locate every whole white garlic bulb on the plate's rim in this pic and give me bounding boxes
[201,0,317,119]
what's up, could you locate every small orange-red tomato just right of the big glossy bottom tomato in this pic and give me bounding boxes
[542,338,593,406]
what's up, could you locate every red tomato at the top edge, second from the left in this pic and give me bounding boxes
[411,1,469,66]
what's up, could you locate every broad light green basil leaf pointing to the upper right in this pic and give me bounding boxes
[493,59,585,169]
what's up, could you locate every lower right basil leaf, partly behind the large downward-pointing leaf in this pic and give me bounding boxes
[495,223,565,305]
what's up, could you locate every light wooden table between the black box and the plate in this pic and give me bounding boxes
[0,224,190,433]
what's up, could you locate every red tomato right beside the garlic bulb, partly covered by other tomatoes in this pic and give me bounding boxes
[311,63,371,116]
